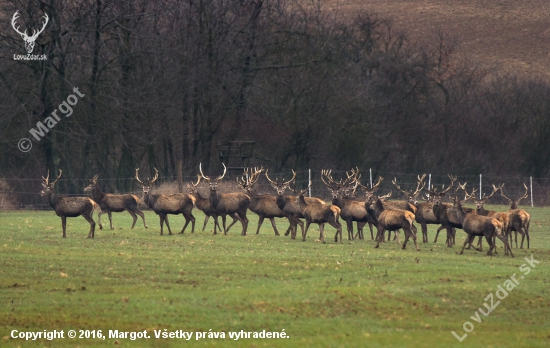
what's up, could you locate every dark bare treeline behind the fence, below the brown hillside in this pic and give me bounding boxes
[0,0,550,205]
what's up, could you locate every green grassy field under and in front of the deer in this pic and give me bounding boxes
[0,207,550,347]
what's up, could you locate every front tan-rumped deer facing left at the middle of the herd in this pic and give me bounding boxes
[296,186,343,243]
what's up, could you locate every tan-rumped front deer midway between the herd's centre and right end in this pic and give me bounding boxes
[365,192,420,250]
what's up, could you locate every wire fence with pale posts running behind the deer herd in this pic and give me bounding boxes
[0,168,550,210]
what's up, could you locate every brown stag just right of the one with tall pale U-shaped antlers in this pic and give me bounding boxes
[237,168,290,236]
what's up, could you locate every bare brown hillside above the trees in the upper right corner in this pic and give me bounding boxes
[326,0,550,78]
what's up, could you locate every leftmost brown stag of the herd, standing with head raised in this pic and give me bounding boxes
[40,169,97,238]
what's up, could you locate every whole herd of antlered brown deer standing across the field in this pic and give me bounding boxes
[37,165,530,257]
